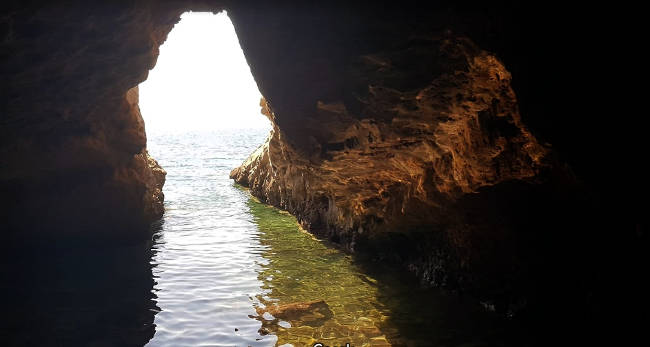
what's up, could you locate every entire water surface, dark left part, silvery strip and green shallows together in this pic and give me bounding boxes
[0,130,516,346]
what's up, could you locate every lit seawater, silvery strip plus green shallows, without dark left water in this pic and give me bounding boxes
[144,129,504,346]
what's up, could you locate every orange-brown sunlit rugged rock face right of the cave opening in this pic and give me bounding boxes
[231,47,547,233]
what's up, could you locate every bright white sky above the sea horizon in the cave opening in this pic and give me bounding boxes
[140,12,270,133]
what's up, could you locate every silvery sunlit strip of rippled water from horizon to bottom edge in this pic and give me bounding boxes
[144,129,274,346]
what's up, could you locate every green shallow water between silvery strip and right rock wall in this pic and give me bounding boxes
[247,190,498,346]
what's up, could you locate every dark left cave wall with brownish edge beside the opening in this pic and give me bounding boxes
[0,4,178,240]
